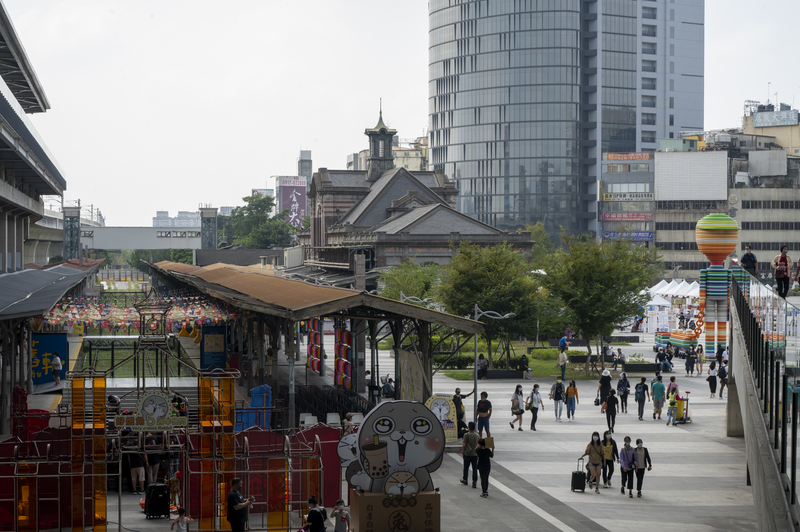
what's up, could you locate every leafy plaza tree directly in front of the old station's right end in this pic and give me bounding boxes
[437,243,536,367]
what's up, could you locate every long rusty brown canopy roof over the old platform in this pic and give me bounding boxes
[151,261,483,334]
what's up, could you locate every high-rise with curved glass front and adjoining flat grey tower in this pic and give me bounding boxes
[429,0,704,235]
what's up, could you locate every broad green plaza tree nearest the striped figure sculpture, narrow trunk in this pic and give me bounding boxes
[542,235,663,376]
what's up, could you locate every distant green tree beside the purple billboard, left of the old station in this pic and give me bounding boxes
[230,195,295,249]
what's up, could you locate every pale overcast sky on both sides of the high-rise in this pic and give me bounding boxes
[3,0,800,226]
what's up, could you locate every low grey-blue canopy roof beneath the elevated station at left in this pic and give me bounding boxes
[0,266,94,320]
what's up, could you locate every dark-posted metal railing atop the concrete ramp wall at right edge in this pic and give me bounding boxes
[731,267,800,515]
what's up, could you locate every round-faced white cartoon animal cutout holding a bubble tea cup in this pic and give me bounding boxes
[340,401,445,495]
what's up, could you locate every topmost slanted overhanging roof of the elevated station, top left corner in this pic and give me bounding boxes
[0,3,50,113]
